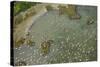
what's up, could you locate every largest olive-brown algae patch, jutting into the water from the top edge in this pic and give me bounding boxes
[58,5,80,19]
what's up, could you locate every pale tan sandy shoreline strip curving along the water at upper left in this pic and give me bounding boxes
[14,4,47,41]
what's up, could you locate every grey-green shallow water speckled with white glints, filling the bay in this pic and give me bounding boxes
[14,6,97,65]
